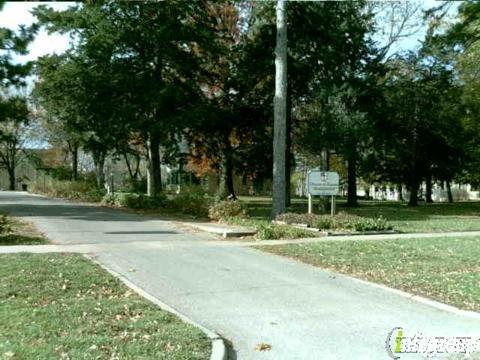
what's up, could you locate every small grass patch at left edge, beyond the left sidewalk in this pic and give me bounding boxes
[0,216,48,246]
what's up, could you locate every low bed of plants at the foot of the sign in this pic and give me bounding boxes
[277,212,392,231]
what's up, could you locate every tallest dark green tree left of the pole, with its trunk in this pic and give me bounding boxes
[36,1,214,196]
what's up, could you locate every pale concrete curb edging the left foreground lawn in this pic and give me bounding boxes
[83,254,227,360]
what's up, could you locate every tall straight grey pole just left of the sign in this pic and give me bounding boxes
[272,0,287,218]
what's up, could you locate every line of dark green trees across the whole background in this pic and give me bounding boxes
[0,0,480,211]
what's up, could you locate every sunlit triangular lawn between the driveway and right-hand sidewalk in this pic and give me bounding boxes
[258,237,480,311]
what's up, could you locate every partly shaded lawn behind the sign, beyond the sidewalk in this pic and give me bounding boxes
[241,197,480,232]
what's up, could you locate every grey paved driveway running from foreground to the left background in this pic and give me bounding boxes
[0,193,480,360]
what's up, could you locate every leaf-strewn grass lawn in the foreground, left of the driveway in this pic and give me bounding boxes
[0,254,211,359]
